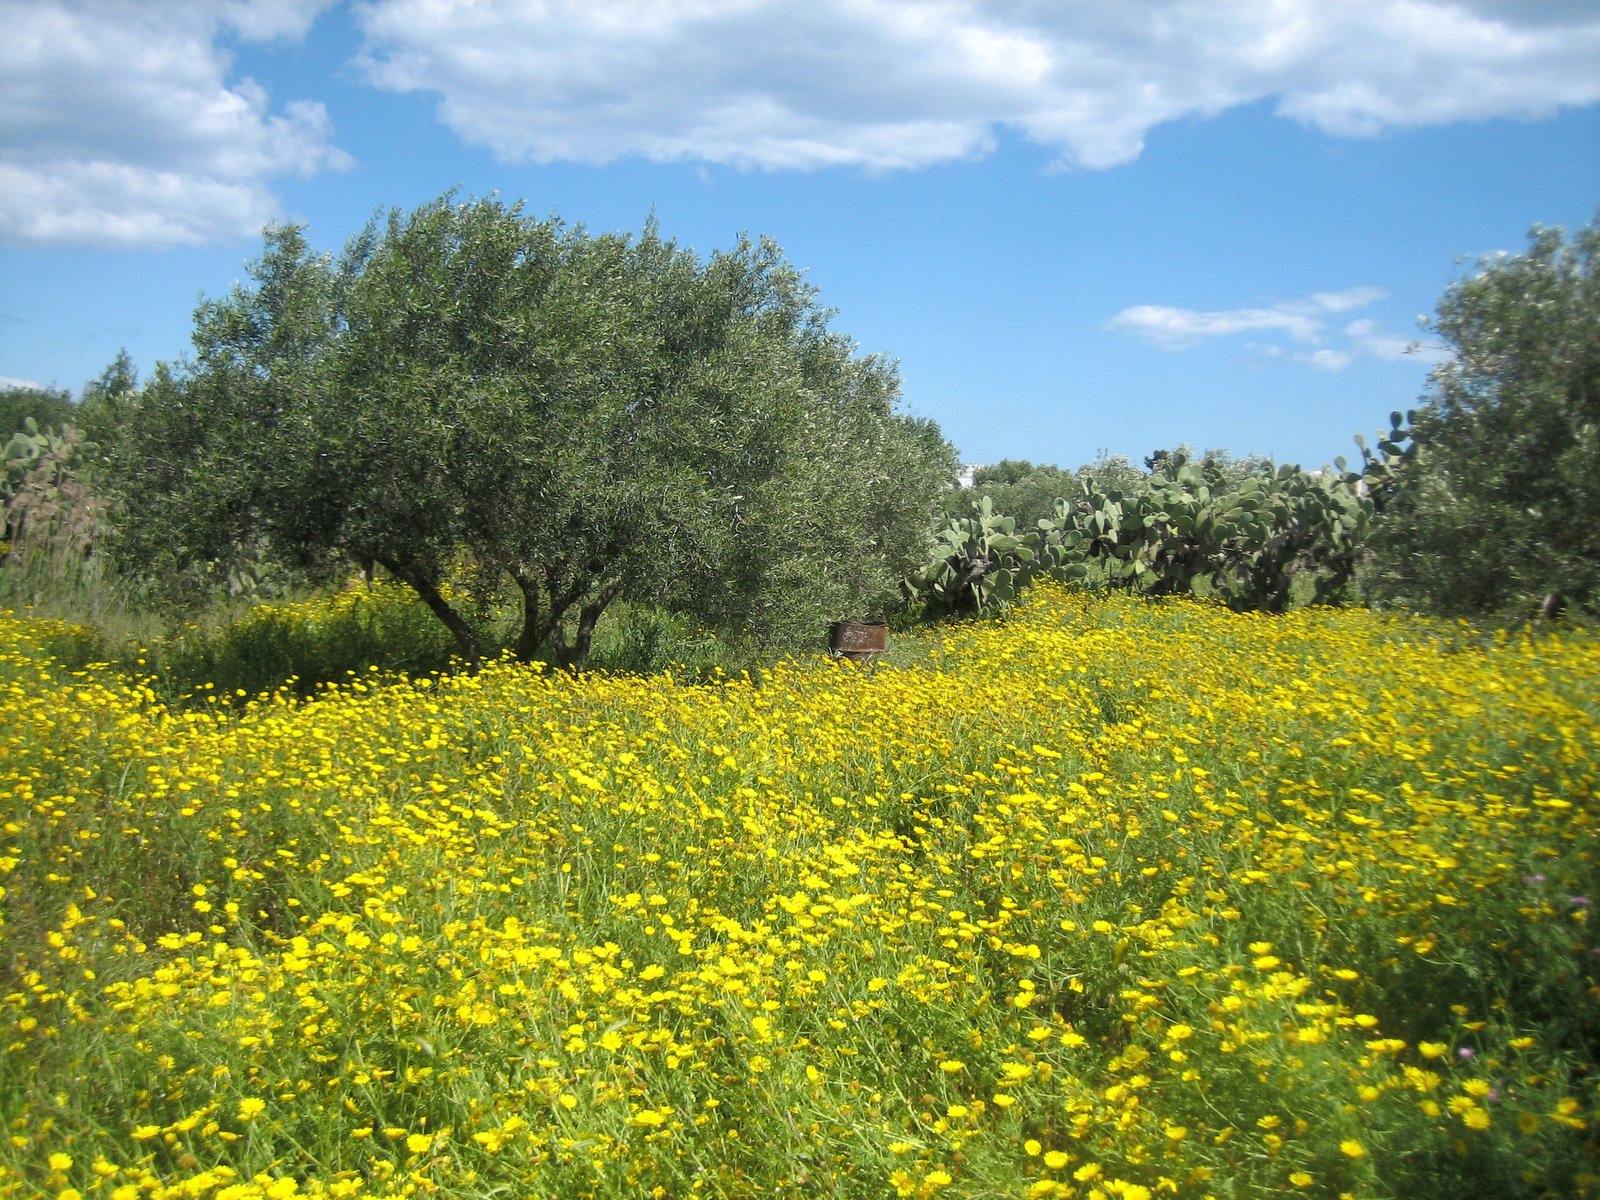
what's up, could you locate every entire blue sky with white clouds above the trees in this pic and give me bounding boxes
[0,0,1600,467]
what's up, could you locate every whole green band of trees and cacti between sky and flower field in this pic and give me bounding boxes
[0,206,1600,666]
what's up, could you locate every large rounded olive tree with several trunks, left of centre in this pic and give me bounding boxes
[112,195,955,666]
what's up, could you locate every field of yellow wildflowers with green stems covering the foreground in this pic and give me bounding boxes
[0,589,1600,1200]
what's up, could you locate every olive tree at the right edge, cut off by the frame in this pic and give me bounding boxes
[1370,219,1600,613]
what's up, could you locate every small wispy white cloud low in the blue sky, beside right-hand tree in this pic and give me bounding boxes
[1106,286,1446,371]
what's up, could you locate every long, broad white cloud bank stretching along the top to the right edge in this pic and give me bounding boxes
[357,0,1600,170]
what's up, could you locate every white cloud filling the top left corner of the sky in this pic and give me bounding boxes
[0,0,349,246]
